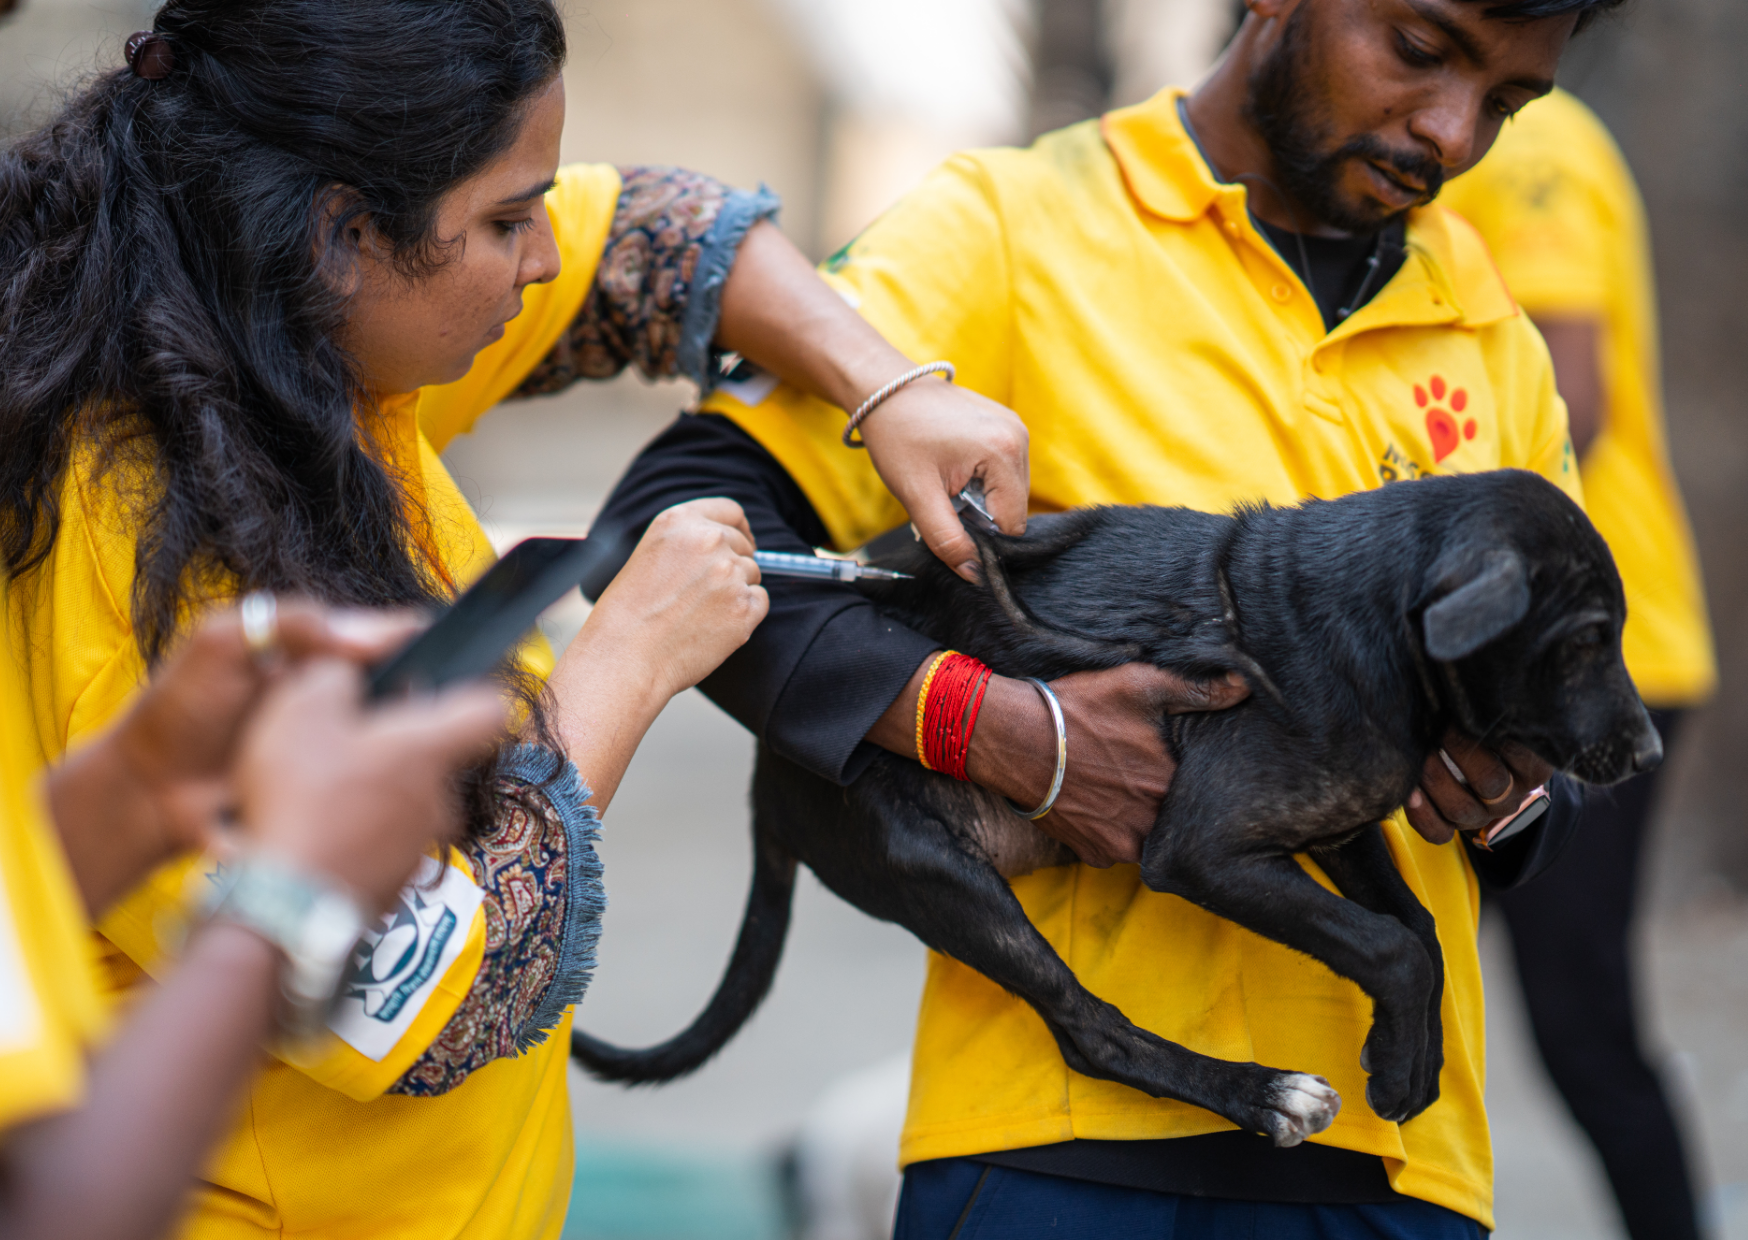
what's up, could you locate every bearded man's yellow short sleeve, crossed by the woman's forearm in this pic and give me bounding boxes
[703,156,1012,549]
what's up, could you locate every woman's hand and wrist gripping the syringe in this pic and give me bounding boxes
[547,498,771,810]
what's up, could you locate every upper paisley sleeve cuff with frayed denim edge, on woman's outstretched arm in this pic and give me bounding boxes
[510,168,778,397]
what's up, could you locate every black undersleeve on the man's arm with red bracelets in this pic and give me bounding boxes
[586,413,937,784]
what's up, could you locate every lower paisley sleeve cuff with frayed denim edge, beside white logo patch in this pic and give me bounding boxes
[388,745,607,1098]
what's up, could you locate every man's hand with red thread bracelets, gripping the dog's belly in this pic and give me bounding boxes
[869,656,1250,867]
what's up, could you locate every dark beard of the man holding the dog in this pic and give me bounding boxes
[1245,5,1444,233]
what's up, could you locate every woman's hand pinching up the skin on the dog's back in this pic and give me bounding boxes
[858,376,1031,581]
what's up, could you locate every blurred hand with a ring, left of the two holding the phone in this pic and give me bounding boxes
[47,598,423,915]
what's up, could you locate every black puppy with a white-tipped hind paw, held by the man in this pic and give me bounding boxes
[573,470,1662,1146]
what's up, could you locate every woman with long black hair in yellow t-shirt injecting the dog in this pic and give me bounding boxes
[0,0,1026,1238]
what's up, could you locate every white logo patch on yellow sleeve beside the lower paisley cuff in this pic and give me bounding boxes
[329,857,486,1062]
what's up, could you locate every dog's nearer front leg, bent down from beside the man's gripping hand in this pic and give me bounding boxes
[1141,783,1433,1123]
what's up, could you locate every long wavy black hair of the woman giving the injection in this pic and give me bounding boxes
[0,0,565,832]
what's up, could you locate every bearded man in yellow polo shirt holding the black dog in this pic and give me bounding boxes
[590,0,1608,1238]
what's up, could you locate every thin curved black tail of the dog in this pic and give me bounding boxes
[570,826,795,1084]
